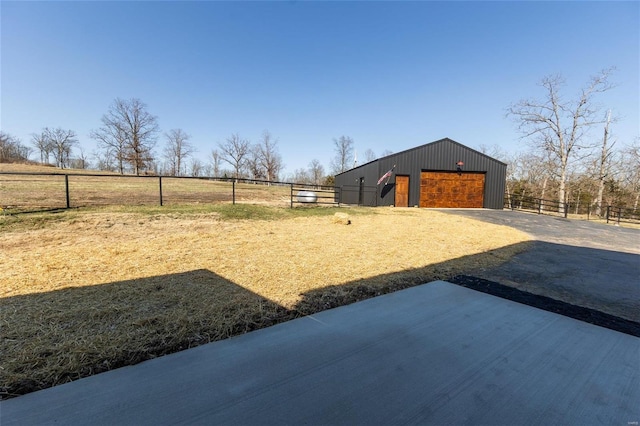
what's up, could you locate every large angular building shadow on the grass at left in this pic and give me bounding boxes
[0,270,295,397]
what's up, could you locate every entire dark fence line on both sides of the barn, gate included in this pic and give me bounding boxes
[0,172,640,223]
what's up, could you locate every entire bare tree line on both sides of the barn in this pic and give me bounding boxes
[0,68,640,215]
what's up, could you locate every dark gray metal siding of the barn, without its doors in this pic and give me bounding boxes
[336,139,507,209]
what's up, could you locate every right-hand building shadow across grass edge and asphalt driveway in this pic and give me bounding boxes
[297,241,640,337]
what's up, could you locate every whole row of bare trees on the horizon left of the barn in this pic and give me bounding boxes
[0,98,375,185]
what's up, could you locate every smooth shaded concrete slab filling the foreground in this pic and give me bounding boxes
[0,281,640,426]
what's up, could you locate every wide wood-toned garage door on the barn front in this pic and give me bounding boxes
[420,172,484,208]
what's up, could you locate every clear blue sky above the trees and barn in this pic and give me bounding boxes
[0,1,640,174]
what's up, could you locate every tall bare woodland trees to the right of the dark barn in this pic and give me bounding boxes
[502,68,640,215]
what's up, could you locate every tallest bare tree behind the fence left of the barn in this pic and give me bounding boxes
[91,98,159,175]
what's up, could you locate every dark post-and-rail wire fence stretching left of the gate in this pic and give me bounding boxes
[0,172,322,213]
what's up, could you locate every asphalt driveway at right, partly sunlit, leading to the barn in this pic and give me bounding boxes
[442,210,640,322]
